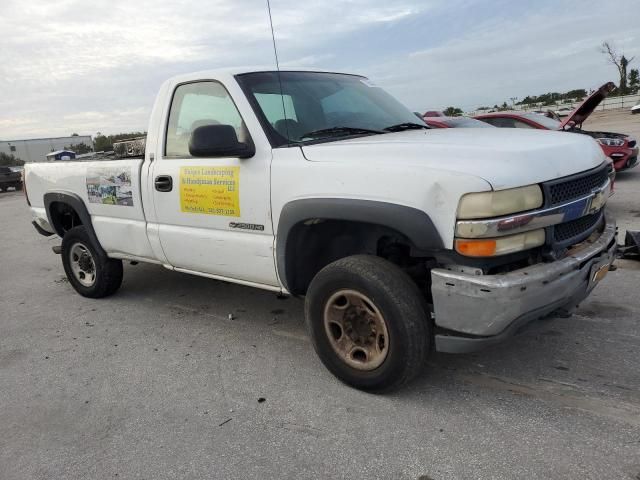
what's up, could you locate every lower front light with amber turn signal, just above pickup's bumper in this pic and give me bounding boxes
[455,229,545,257]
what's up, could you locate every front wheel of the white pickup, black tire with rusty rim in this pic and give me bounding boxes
[305,255,432,392]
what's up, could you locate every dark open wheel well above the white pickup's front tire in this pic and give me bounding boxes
[281,219,429,295]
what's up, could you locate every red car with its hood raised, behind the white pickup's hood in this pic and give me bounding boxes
[474,82,638,171]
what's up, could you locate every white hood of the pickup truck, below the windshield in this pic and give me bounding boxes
[302,128,605,190]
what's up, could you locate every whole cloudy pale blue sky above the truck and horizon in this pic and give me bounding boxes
[0,0,640,140]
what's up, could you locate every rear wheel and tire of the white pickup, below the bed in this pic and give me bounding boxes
[61,226,122,298]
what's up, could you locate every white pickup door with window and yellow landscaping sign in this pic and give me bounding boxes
[152,81,278,287]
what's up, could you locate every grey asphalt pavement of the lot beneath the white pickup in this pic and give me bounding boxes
[0,168,640,480]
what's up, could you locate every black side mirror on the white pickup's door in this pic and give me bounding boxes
[189,125,256,158]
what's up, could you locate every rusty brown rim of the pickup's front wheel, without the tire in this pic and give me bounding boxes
[324,290,389,370]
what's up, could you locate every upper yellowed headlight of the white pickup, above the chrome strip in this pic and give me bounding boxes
[458,185,543,220]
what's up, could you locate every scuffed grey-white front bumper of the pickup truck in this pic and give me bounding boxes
[431,217,616,353]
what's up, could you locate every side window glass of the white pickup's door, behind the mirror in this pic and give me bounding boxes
[165,82,248,158]
